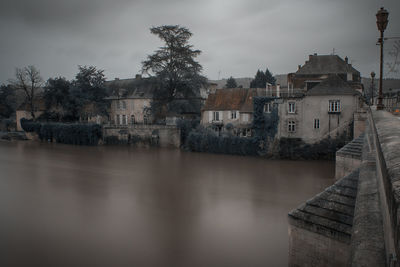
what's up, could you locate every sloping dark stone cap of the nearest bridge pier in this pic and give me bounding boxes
[289,169,359,243]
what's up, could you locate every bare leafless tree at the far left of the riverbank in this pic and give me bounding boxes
[11,65,43,119]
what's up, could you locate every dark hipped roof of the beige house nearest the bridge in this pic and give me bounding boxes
[306,75,359,96]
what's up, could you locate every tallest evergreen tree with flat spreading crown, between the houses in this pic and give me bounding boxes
[142,25,206,117]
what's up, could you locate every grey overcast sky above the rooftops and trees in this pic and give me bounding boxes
[0,0,400,83]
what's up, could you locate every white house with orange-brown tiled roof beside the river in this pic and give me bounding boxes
[201,88,266,136]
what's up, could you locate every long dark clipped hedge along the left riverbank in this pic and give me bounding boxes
[21,119,102,145]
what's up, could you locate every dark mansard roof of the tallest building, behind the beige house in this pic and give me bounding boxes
[296,55,360,75]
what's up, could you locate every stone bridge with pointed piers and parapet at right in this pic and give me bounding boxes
[289,109,400,267]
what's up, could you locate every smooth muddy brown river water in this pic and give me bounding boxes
[0,142,334,267]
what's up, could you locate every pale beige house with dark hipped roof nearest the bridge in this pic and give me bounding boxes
[278,74,362,143]
